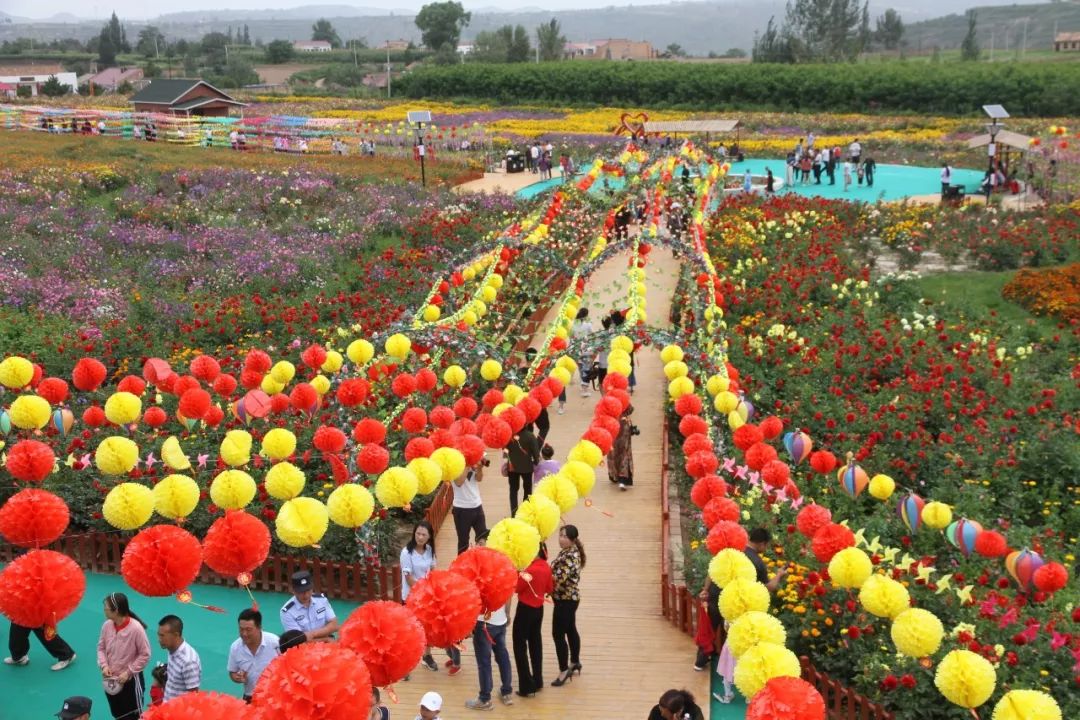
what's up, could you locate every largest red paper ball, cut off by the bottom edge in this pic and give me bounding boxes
[251,642,372,720]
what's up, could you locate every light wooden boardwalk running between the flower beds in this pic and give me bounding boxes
[391,246,708,720]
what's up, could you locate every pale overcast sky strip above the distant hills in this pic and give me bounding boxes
[6,0,630,19]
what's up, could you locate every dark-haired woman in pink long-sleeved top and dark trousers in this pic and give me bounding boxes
[97,593,150,720]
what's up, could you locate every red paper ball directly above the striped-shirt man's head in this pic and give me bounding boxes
[120,525,202,597]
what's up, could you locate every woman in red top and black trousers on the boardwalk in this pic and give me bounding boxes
[512,543,554,697]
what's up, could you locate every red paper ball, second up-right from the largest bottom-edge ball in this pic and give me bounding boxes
[406,570,481,648]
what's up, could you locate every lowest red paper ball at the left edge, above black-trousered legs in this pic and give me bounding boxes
[0,549,86,627]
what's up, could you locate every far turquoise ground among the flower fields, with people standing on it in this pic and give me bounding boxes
[516,159,983,202]
